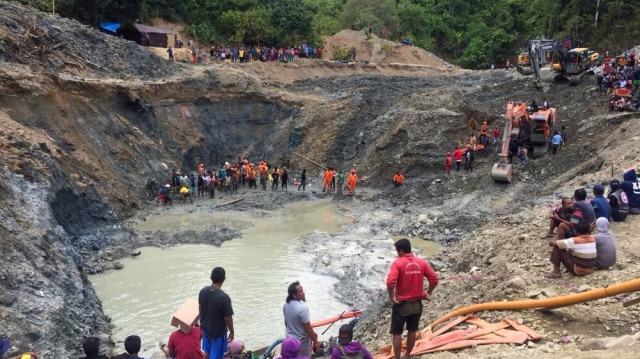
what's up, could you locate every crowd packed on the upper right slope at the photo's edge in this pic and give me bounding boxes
[592,51,640,112]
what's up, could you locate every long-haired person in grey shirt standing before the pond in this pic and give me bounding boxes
[282,281,320,357]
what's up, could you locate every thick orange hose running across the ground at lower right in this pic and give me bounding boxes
[425,278,640,331]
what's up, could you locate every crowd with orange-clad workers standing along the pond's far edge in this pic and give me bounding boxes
[157,157,358,205]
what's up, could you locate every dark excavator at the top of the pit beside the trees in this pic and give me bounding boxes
[518,38,598,85]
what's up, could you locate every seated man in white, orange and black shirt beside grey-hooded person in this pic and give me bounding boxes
[546,218,597,278]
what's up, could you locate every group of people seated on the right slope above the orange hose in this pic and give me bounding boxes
[544,169,640,278]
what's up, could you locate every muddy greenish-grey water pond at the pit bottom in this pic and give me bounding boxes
[90,201,349,357]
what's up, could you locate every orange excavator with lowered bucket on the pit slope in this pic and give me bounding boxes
[491,101,556,183]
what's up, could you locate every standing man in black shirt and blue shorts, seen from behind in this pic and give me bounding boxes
[198,267,234,359]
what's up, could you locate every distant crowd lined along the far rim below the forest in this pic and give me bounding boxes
[167,43,322,64]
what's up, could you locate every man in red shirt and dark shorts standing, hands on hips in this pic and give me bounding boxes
[387,238,438,359]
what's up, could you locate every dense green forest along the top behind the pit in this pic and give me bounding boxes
[13,0,640,68]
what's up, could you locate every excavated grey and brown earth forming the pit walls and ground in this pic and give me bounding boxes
[0,2,640,358]
